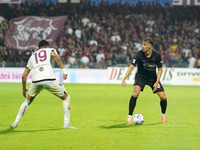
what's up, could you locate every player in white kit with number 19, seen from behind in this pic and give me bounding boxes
[10,40,76,129]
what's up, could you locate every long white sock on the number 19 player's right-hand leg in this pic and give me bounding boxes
[63,95,71,126]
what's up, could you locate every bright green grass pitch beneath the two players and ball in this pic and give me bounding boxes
[0,83,200,150]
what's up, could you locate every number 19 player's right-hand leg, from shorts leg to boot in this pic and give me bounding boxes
[46,80,76,129]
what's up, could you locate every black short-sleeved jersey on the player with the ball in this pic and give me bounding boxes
[132,50,162,80]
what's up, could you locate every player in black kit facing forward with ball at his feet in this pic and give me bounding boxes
[121,37,167,124]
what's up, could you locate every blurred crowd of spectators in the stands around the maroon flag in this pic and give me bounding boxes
[0,2,200,69]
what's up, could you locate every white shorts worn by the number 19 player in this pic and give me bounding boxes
[28,80,67,97]
